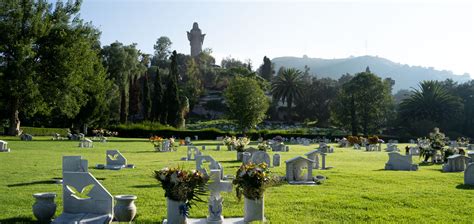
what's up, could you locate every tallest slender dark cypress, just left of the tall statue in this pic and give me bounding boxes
[164,51,181,127]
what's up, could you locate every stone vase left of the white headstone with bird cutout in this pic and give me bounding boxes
[33,193,56,223]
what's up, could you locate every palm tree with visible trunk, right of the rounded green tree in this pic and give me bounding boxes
[272,68,304,120]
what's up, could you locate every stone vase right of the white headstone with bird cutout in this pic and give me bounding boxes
[114,195,137,222]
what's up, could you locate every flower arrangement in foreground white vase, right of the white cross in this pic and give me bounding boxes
[232,163,270,200]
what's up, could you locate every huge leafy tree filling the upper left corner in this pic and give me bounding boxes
[0,0,107,135]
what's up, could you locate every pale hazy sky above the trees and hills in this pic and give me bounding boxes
[81,0,474,77]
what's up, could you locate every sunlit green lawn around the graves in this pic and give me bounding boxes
[0,137,474,223]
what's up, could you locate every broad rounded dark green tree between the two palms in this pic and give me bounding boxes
[332,68,393,135]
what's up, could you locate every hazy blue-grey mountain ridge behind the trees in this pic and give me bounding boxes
[272,56,471,92]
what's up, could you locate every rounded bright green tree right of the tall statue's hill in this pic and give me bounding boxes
[224,76,269,133]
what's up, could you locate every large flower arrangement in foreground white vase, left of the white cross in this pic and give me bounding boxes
[155,167,209,211]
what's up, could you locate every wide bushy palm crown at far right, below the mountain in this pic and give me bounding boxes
[400,81,463,123]
